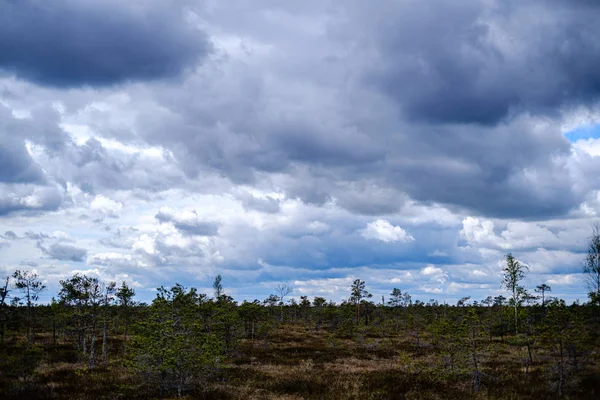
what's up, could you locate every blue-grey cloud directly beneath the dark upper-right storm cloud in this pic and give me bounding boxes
[383,120,576,218]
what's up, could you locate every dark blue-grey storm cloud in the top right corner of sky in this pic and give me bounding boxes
[353,0,600,124]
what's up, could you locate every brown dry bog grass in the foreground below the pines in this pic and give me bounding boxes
[0,325,600,400]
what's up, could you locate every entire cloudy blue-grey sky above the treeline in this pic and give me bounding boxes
[0,0,600,303]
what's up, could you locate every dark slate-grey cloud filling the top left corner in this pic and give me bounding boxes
[0,0,210,87]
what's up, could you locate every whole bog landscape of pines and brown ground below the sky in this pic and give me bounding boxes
[0,229,600,399]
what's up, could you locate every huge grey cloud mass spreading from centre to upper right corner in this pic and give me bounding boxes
[116,0,600,219]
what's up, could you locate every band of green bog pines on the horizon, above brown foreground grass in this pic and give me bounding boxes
[0,230,600,395]
